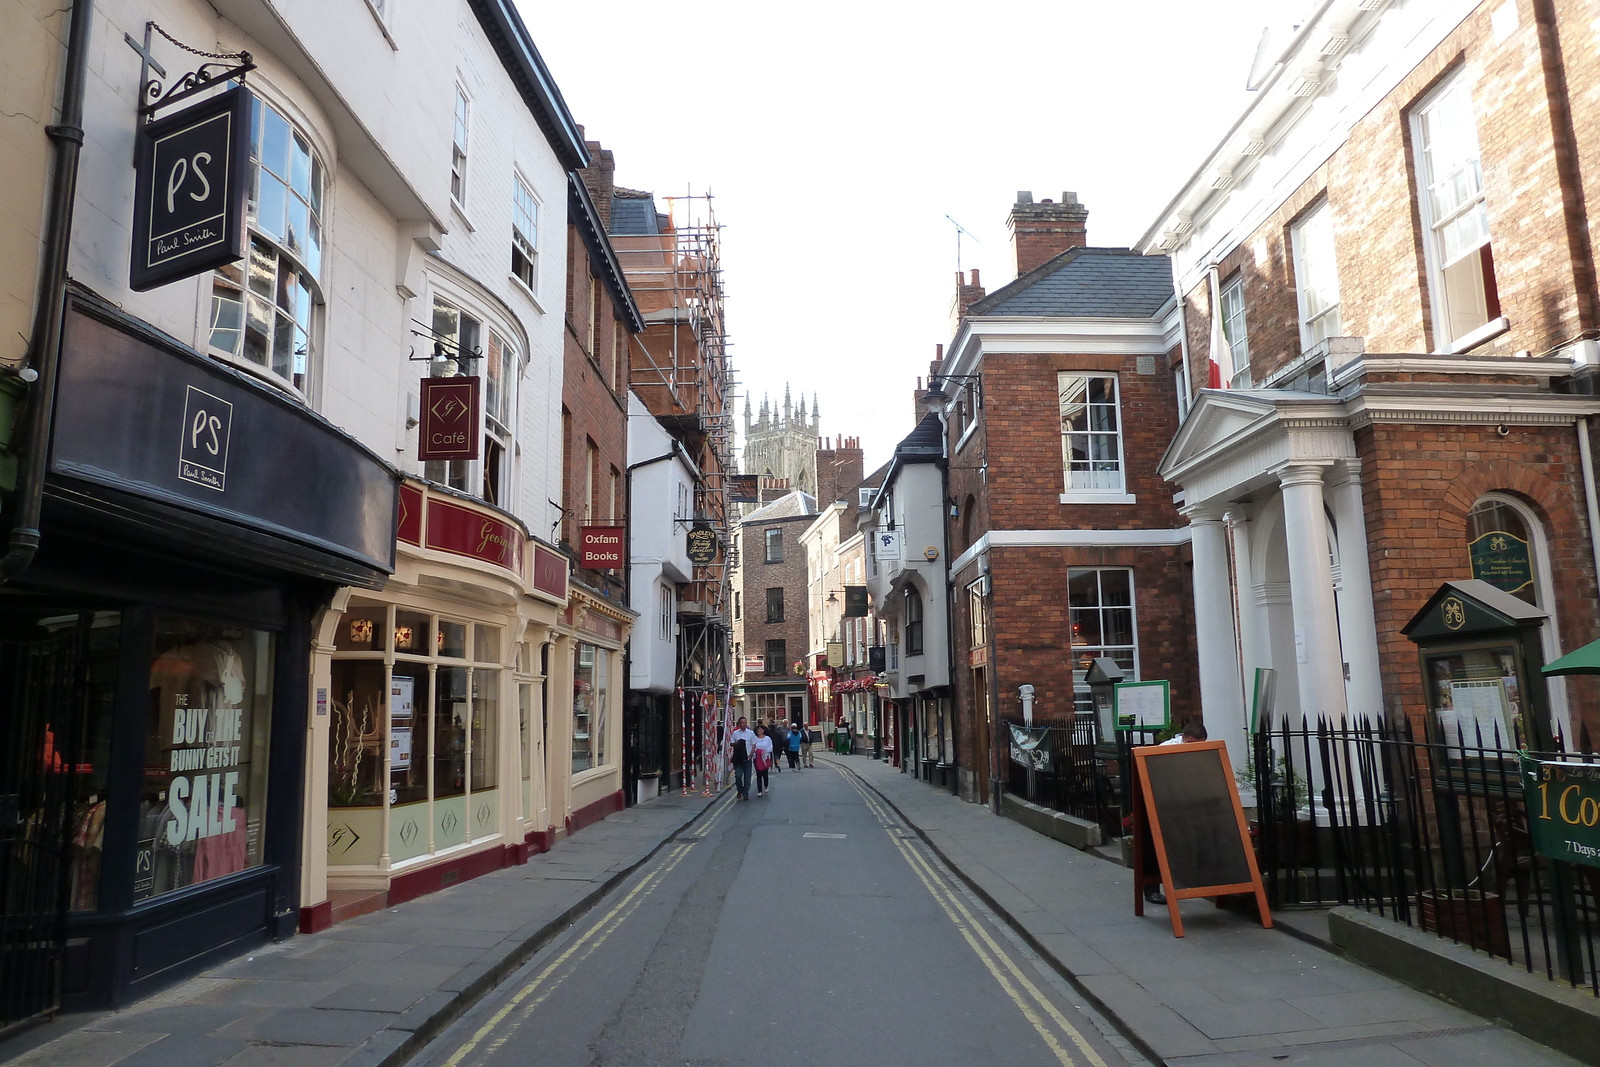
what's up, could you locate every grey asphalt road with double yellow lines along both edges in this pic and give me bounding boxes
[413,765,1146,1067]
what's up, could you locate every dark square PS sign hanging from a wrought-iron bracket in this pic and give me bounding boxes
[128,85,251,293]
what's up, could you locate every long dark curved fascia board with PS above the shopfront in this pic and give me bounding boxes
[50,304,398,584]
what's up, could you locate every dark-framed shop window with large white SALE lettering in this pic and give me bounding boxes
[142,616,274,901]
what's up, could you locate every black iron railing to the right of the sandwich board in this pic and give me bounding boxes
[1243,721,1600,997]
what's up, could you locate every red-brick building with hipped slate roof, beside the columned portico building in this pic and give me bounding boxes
[922,192,1198,801]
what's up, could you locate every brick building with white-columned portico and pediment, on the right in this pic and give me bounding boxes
[1139,0,1600,767]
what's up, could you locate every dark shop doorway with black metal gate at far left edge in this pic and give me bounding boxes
[0,614,104,1035]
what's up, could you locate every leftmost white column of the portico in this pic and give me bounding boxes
[1184,506,1250,769]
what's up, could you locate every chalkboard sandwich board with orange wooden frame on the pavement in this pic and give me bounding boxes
[1133,741,1272,937]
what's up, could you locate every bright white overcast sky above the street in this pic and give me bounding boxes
[518,0,1286,470]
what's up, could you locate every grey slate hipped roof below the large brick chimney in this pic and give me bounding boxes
[966,248,1173,318]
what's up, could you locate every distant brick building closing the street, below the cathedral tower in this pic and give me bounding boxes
[733,490,816,721]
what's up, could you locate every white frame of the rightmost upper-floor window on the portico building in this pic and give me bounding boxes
[1408,70,1510,355]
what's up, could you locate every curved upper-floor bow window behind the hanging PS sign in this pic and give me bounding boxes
[210,98,326,390]
